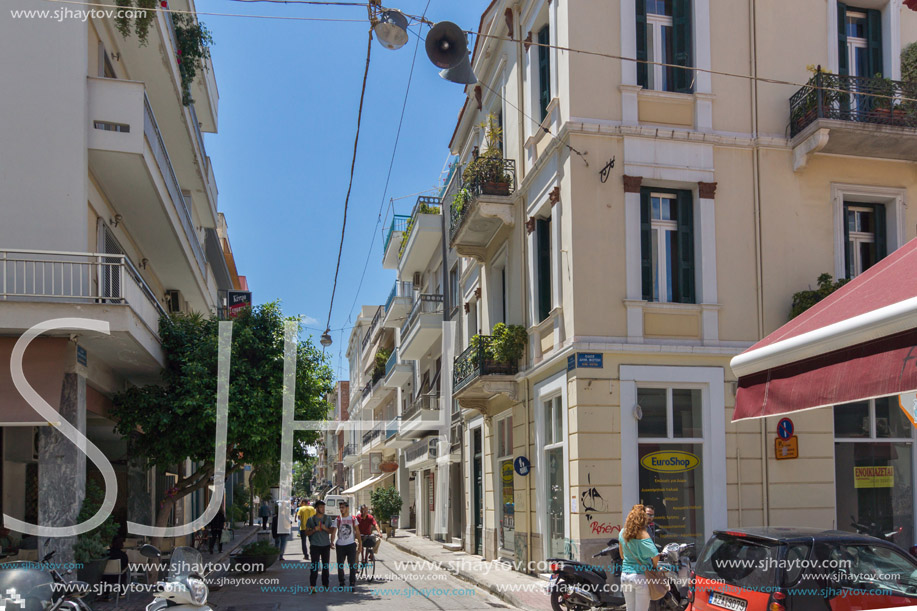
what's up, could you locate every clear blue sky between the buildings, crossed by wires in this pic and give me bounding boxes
[196,0,488,379]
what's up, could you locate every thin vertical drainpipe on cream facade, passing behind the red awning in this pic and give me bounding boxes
[737,0,770,526]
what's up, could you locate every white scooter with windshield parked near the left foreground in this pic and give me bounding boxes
[140,545,212,611]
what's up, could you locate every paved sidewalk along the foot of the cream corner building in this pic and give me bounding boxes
[380,529,551,611]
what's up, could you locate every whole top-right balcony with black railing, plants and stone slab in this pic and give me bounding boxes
[790,71,917,170]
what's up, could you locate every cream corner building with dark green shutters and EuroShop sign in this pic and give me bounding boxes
[352,0,917,570]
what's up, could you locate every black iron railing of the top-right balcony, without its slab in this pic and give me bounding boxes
[790,72,917,138]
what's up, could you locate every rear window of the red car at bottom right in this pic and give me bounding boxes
[694,535,780,589]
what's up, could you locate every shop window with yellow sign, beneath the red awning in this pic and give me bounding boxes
[834,397,915,547]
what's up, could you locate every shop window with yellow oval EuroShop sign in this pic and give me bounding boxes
[637,388,705,549]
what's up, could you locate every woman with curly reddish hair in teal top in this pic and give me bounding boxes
[618,505,659,611]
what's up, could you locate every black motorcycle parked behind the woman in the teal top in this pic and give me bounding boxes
[548,539,694,611]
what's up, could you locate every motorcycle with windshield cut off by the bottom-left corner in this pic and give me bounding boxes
[0,552,92,611]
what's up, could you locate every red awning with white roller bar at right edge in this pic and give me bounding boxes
[731,239,917,421]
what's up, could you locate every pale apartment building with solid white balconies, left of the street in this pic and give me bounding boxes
[0,0,247,559]
